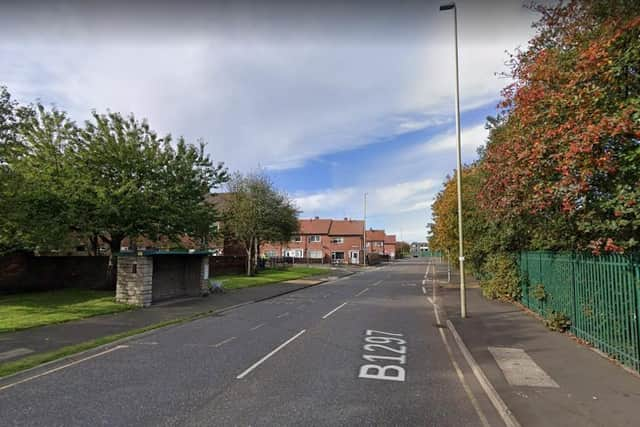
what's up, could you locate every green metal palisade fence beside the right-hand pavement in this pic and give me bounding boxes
[519,252,640,371]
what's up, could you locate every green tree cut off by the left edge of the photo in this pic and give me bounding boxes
[0,95,78,251]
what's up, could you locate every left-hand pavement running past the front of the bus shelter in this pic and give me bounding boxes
[0,270,353,370]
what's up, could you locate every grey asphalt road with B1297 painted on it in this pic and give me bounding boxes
[0,260,493,426]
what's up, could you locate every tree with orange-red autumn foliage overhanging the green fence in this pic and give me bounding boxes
[480,0,640,252]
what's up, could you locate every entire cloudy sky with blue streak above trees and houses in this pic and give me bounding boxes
[0,0,538,242]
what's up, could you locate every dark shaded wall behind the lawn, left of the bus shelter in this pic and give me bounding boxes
[0,253,114,294]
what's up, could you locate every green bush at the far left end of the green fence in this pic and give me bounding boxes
[481,254,520,301]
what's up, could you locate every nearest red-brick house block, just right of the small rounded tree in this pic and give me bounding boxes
[260,217,364,264]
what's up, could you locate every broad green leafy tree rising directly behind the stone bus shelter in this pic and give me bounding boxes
[73,112,227,274]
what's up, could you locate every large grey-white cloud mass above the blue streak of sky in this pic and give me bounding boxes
[0,1,531,174]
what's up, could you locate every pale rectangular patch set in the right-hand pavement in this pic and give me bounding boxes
[489,347,560,388]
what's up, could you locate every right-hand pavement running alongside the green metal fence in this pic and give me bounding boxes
[438,267,640,426]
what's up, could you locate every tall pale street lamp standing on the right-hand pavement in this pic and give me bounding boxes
[440,3,467,318]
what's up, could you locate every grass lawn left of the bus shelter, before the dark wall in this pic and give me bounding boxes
[0,289,131,333]
